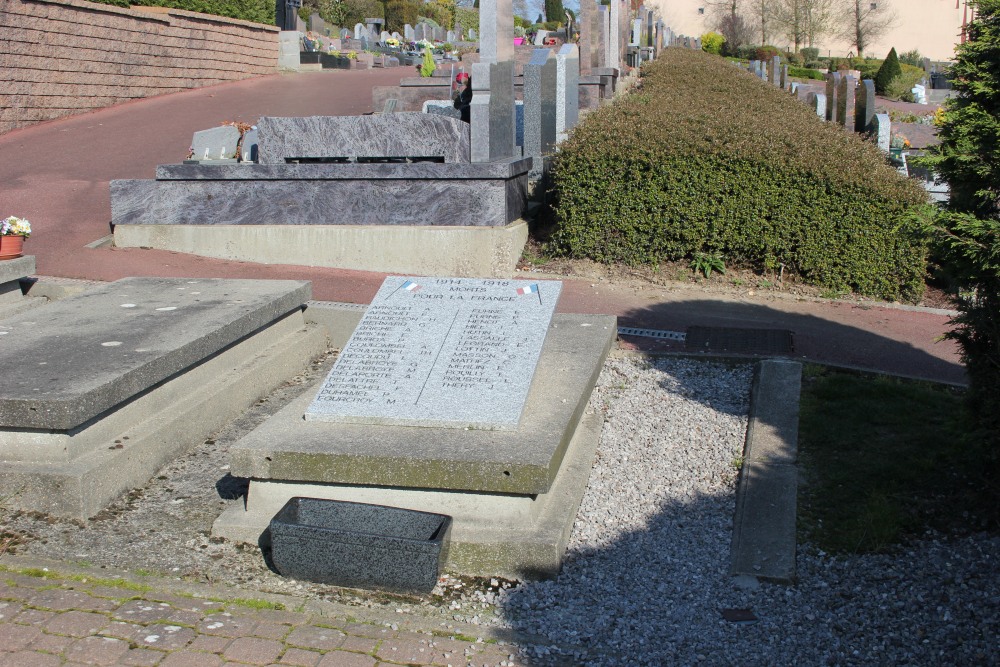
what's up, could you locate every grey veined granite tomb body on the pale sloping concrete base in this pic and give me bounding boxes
[110,159,531,227]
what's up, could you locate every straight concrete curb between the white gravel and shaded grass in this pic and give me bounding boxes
[730,360,802,583]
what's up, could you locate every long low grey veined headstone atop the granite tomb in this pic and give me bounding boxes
[257,112,469,164]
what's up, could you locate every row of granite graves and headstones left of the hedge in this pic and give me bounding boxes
[111,0,704,277]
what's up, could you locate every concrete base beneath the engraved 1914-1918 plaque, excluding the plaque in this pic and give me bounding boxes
[213,313,616,578]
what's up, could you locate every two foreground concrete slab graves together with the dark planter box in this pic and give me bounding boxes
[0,268,616,592]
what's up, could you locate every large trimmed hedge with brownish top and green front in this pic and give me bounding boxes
[549,48,927,300]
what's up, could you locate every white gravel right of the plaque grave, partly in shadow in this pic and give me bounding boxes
[463,358,1000,665]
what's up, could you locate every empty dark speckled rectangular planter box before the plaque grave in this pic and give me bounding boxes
[270,497,451,593]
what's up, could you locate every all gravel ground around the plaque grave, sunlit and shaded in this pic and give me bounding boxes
[0,356,1000,665]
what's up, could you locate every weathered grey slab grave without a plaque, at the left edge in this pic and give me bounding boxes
[0,278,327,519]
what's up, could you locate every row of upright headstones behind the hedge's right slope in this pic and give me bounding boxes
[748,56,948,202]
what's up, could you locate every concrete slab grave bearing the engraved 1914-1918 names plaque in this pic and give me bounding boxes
[213,284,616,577]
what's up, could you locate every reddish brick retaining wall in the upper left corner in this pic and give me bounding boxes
[0,0,279,133]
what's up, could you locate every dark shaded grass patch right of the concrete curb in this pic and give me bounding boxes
[798,366,996,553]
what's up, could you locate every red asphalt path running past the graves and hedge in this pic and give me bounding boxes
[0,68,966,383]
